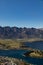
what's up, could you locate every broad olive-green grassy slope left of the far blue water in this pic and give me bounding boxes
[0,39,20,49]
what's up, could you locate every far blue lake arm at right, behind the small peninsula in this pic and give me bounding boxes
[24,41,43,50]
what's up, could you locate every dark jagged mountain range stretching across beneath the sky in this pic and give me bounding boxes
[0,26,43,39]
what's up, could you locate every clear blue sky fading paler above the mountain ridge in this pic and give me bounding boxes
[0,0,43,28]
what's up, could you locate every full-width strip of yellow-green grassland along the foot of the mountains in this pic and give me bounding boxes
[0,38,43,49]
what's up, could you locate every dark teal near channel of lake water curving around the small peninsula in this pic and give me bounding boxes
[0,50,43,65]
